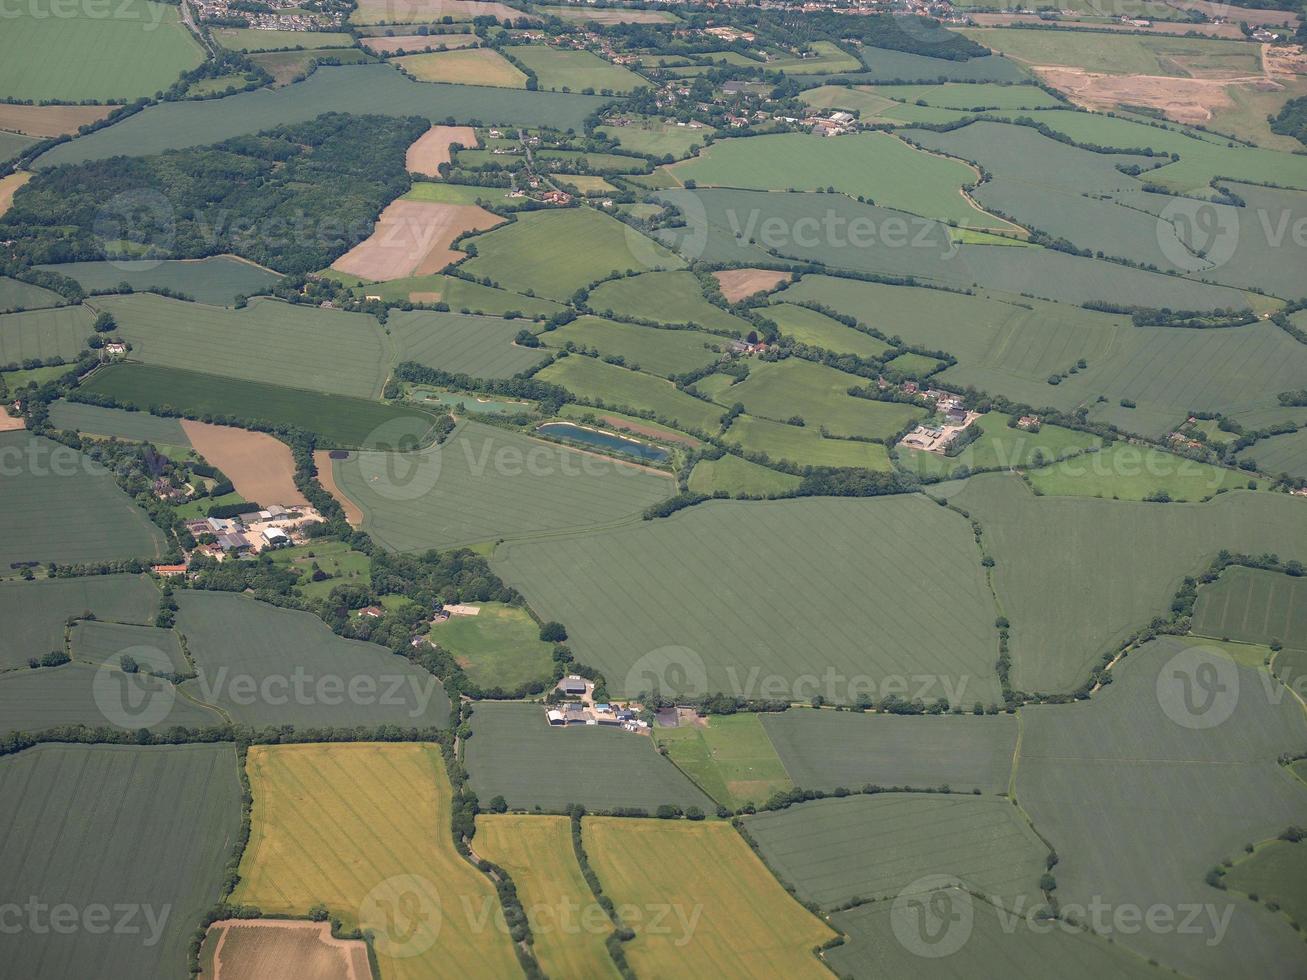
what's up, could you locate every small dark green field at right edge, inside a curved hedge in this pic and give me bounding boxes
[1193,564,1307,649]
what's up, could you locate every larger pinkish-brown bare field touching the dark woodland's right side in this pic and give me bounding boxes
[332,200,503,282]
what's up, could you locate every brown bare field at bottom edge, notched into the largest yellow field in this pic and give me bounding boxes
[207,919,372,980]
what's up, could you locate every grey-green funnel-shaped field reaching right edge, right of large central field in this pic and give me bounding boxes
[945,474,1307,691]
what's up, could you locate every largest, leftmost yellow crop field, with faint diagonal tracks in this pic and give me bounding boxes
[231,742,519,980]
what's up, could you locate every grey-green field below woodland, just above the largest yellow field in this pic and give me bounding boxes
[176,591,450,728]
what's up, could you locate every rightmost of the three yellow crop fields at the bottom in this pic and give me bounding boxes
[582,817,835,980]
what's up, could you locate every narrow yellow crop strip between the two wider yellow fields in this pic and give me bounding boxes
[473,814,620,979]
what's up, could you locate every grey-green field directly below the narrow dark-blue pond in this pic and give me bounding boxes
[335,421,676,551]
